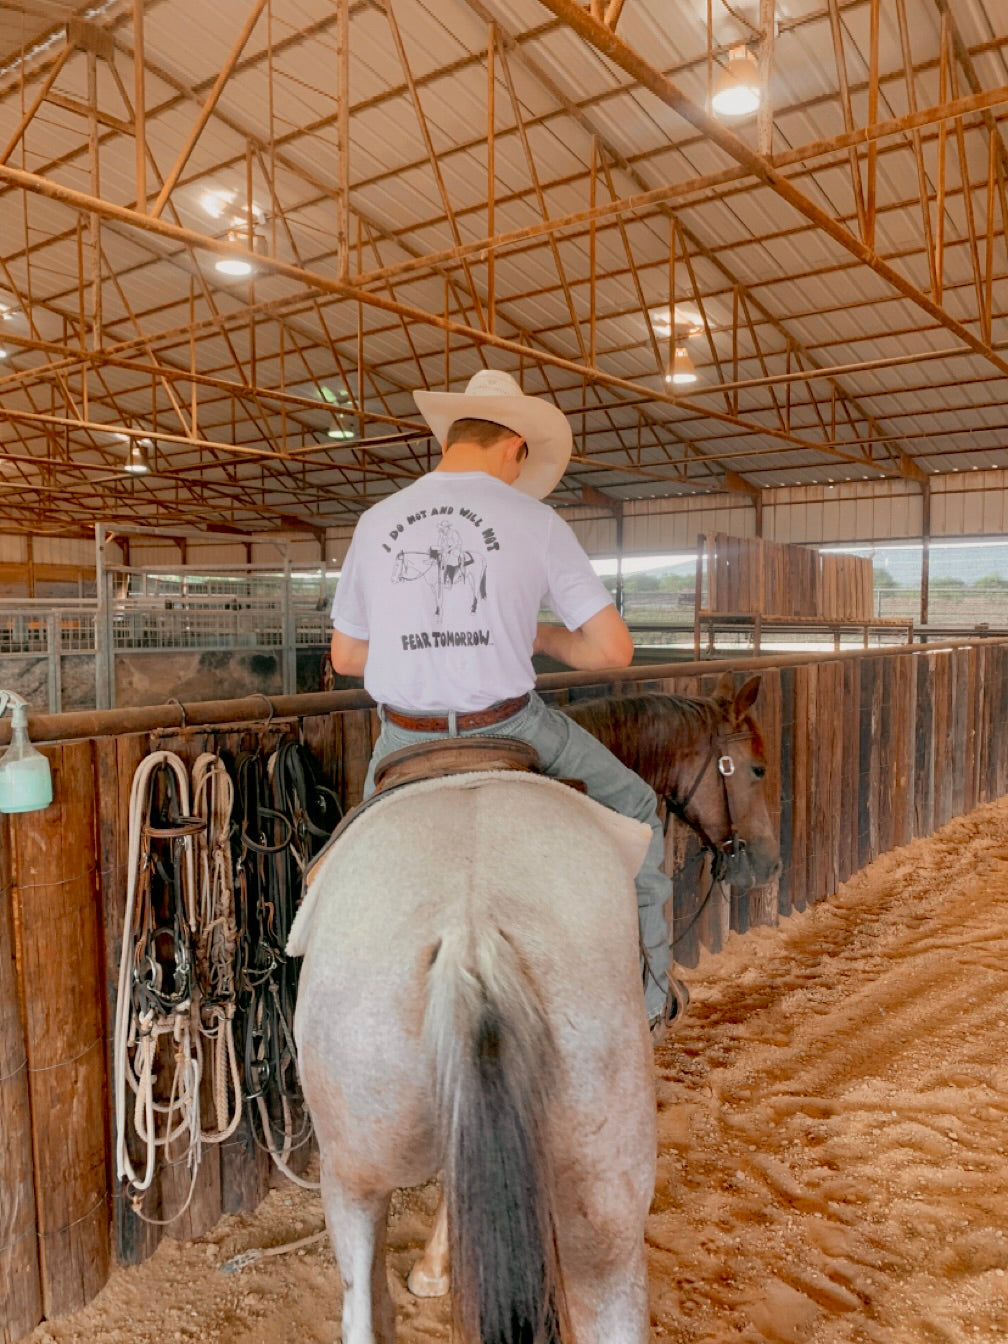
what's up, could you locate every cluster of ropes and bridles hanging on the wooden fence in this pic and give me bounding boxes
[113,742,340,1223]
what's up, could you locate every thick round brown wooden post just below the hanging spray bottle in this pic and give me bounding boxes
[9,742,109,1317]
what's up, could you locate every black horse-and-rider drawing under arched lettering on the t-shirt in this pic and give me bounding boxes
[383,505,499,625]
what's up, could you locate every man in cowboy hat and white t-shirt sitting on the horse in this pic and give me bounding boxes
[332,368,684,1040]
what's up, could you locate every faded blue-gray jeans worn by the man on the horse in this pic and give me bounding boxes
[364,691,672,1019]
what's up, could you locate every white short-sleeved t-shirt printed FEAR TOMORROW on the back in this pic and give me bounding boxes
[332,472,613,714]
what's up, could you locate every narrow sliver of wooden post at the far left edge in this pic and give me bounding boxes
[0,816,42,1344]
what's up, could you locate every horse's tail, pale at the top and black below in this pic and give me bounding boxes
[426,929,570,1344]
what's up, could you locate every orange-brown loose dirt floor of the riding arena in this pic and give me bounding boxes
[30,800,1008,1344]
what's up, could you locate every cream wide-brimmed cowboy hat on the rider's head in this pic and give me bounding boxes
[413,368,574,500]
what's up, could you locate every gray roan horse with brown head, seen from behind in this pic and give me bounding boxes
[289,672,778,1344]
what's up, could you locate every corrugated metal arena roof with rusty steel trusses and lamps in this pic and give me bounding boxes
[0,0,1008,531]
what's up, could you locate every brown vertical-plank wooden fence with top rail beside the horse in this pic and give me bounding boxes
[0,641,1008,1344]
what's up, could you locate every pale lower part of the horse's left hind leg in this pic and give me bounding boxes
[323,1168,395,1344]
